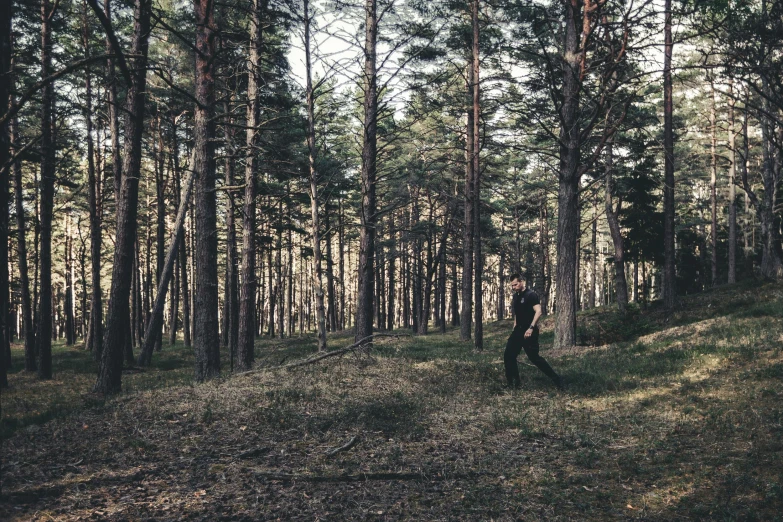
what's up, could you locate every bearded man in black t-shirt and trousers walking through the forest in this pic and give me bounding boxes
[503,274,563,390]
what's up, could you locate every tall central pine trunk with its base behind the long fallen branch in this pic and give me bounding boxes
[356,0,378,342]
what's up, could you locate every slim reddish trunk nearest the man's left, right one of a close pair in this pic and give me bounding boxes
[471,0,484,350]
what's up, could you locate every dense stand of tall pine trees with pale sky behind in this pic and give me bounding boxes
[0,0,783,394]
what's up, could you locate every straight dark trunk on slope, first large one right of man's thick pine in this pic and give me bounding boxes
[662,0,677,310]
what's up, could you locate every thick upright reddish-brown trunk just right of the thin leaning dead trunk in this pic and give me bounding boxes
[193,0,220,381]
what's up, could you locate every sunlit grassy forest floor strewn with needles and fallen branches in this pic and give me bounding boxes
[0,284,783,521]
